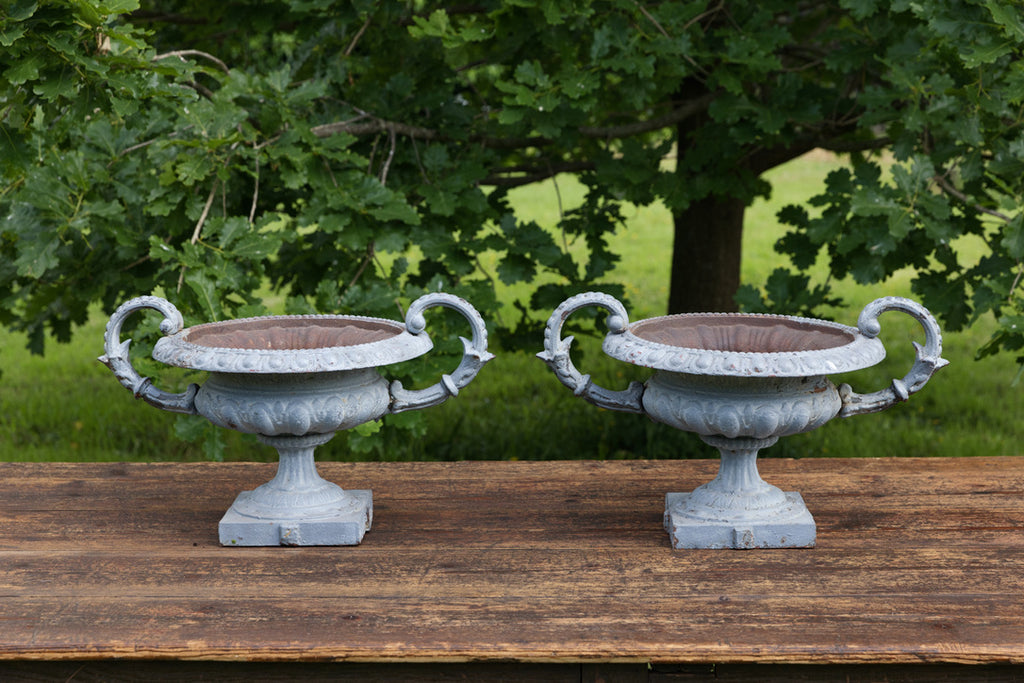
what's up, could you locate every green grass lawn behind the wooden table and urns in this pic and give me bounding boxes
[0,155,1024,461]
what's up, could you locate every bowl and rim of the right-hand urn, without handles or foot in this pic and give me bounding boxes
[603,313,886,439]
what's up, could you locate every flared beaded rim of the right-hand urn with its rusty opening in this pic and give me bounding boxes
[603,313,886,377]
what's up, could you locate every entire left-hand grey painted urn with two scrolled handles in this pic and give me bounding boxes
[99,293,494,546]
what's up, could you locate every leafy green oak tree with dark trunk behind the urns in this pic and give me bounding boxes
[6,0,1024,378]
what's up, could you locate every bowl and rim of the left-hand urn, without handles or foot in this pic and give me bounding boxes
[153,315,432,436]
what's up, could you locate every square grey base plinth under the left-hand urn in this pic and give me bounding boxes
[218,489,374,546]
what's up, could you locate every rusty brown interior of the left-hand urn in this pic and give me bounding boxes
[184,317,404,351]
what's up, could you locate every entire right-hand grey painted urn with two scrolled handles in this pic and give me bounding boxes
[538,292,947,548]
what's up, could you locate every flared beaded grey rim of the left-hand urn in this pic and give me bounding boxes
[153,315,433,374]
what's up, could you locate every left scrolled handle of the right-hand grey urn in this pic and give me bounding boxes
[537,292,644,413]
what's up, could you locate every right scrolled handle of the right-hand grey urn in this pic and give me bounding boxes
[839,297,949,418]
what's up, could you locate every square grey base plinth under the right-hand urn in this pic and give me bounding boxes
[665,492,817,550]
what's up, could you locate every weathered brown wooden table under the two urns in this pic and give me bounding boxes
[0,457,1024,681]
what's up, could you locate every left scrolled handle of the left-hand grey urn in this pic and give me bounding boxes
[99,296,199,415]
